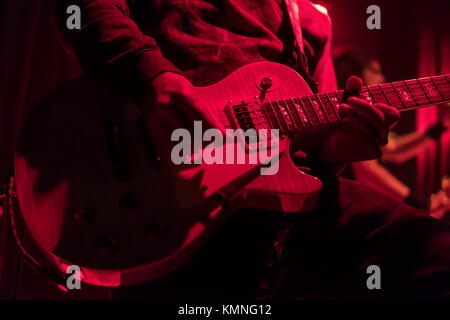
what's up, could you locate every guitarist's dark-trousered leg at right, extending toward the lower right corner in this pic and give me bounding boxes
[279,179,450,298]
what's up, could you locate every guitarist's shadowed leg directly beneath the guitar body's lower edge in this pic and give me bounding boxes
[113,210,284,299]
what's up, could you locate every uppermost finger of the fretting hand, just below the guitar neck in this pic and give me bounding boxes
[339,97,385,131]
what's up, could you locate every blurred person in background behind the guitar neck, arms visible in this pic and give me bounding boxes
[334,50,450,218]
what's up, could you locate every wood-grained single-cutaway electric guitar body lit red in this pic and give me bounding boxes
[15,62,321,286]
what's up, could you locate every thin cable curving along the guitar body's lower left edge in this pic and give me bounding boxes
[6,177,68,292]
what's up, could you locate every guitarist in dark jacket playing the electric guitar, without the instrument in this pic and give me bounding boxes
[54,0,450,298]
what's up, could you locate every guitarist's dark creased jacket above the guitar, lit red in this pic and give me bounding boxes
[58,0,336,93]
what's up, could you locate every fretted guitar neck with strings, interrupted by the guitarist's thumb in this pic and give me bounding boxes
[262,75,450,133]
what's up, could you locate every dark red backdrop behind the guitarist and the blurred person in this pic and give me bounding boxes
[0,0,450,298]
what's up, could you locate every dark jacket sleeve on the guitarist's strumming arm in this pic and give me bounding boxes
[57,0,180,97]
